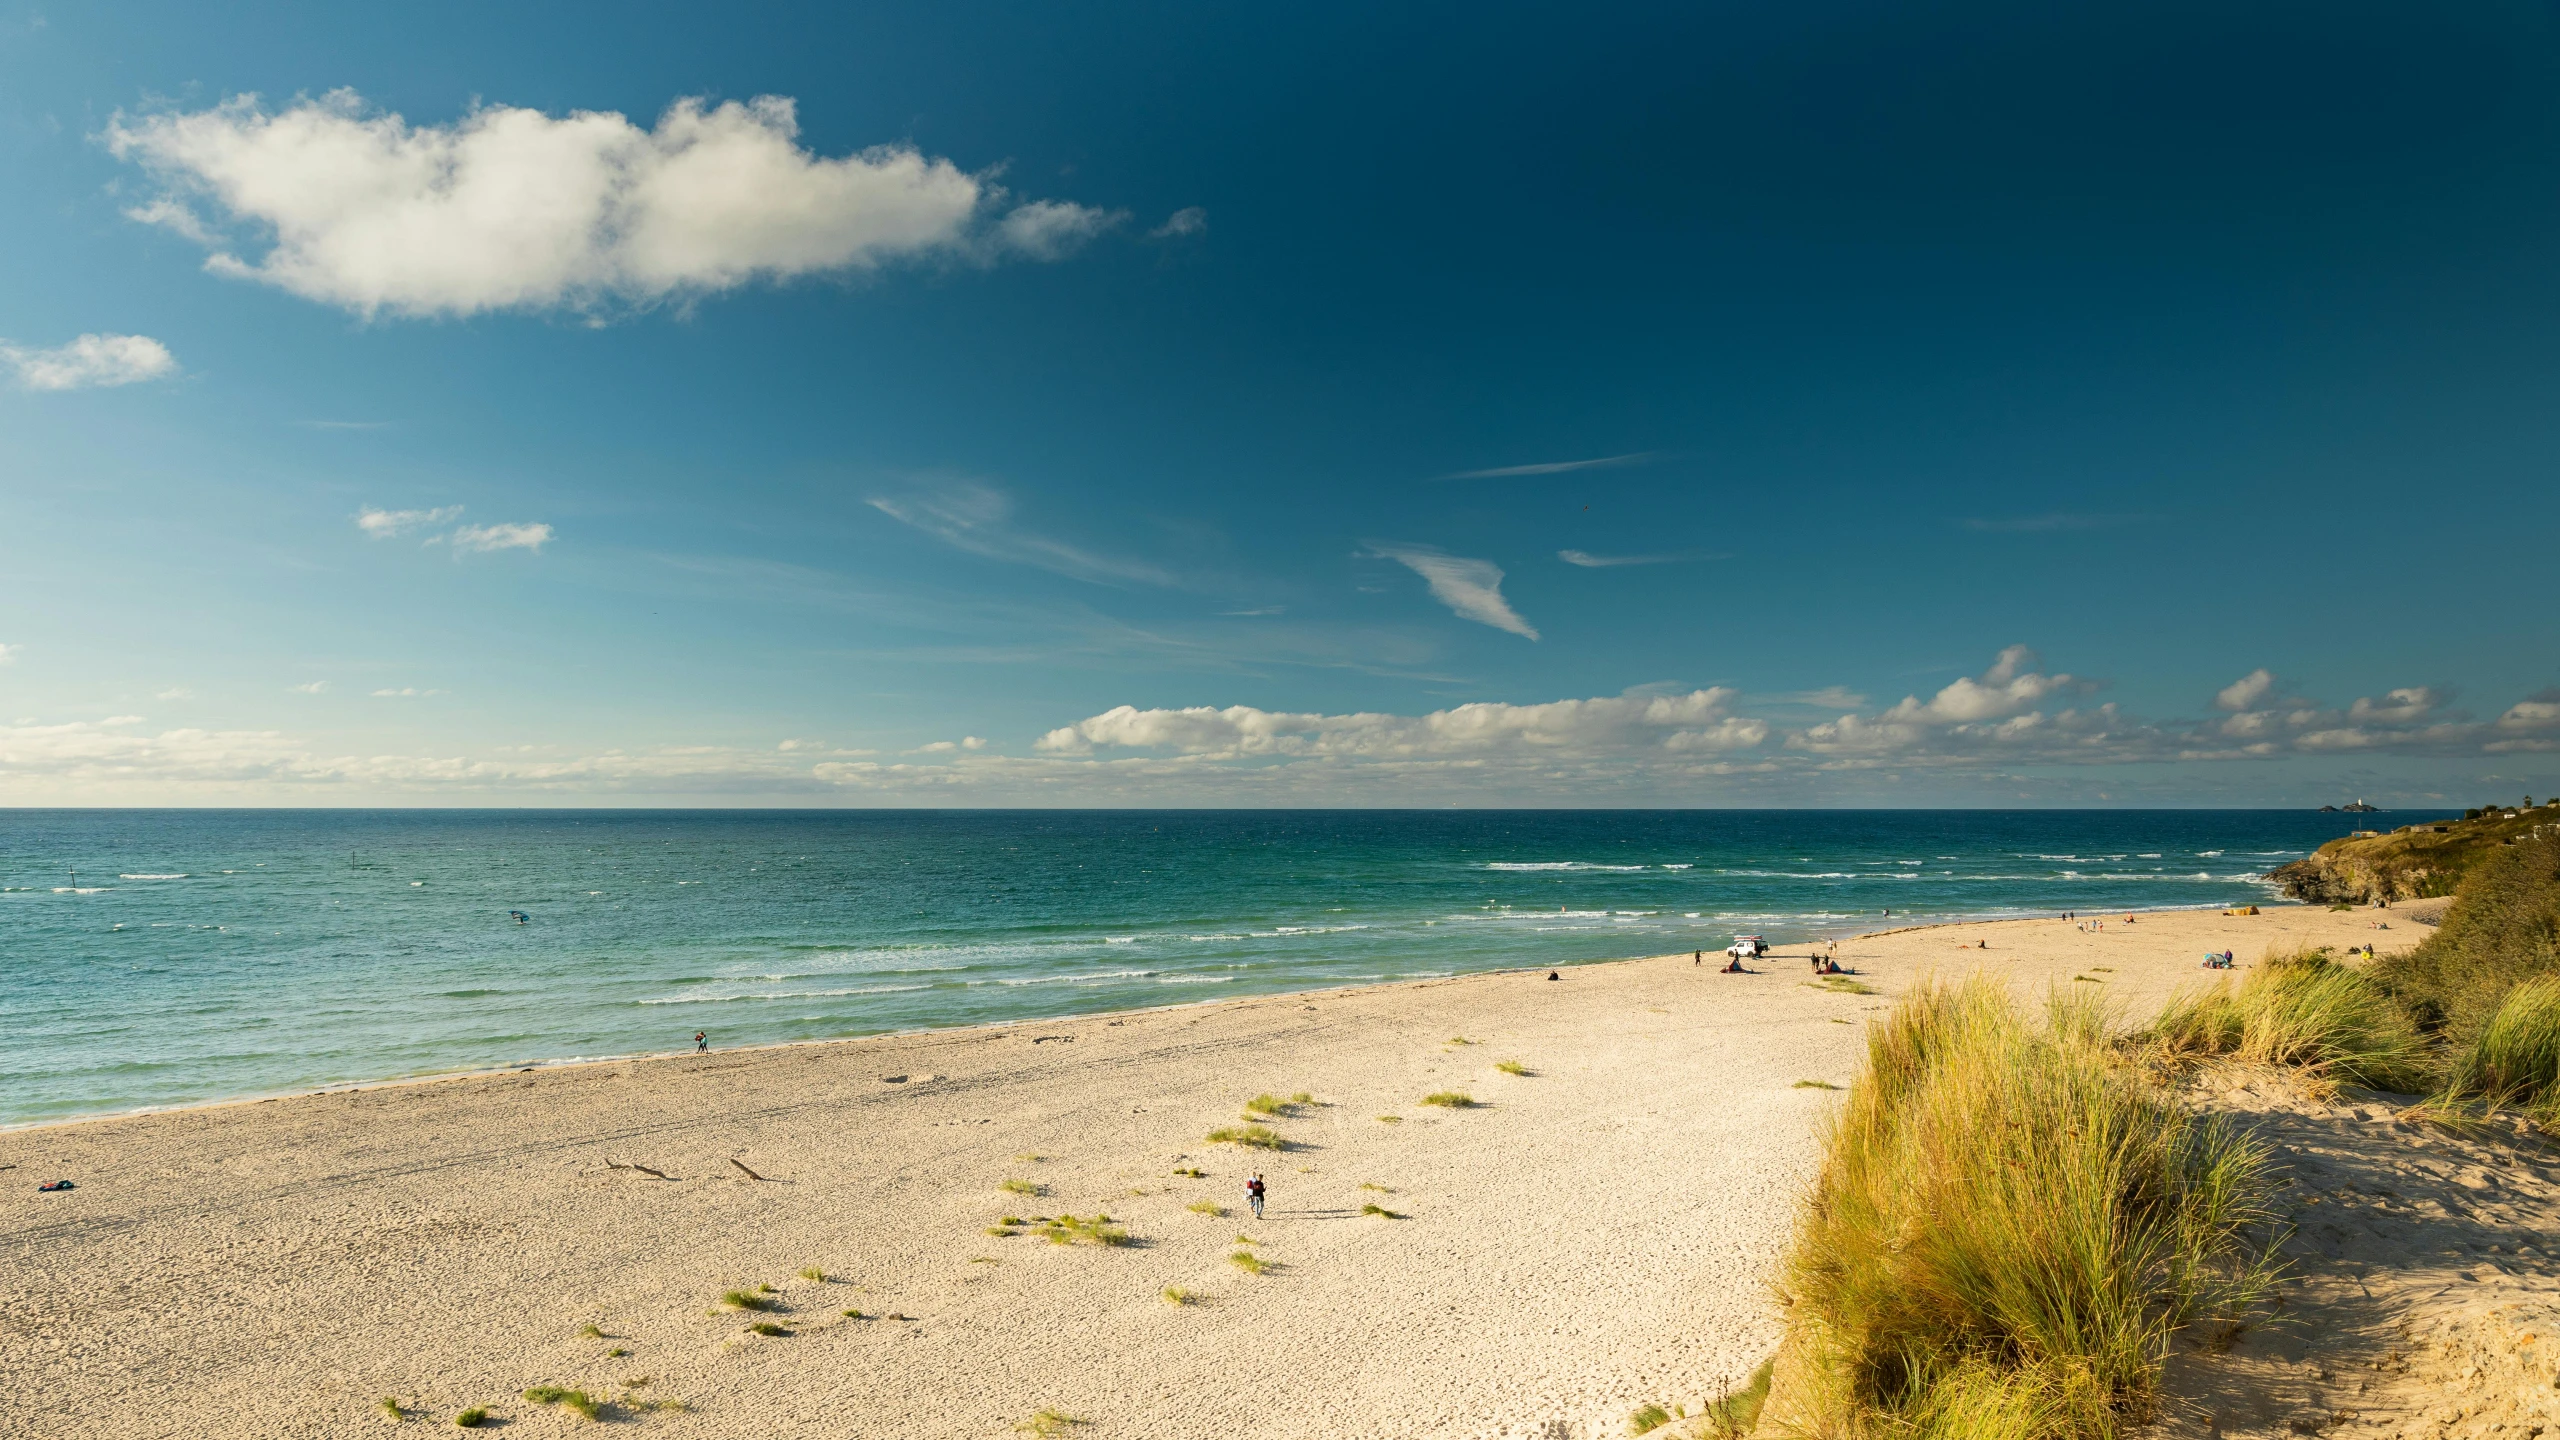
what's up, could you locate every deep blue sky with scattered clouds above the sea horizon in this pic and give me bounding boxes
[0,0,2560,807]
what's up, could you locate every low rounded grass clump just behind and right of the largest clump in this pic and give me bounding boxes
[2153,951,2429,1092]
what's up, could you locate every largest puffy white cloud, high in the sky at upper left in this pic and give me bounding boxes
[105,90,1119,315]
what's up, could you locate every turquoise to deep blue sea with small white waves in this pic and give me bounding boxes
[0,810,2406,1125]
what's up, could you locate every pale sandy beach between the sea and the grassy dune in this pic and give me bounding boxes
[0,907,2424,1440]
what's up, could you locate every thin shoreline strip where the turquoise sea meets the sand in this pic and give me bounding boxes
[0,899,2299,1135]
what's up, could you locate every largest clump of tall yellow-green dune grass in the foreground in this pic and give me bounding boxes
[1782,979,2273,1440]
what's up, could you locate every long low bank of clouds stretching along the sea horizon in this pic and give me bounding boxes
[0,646,2560,805]
